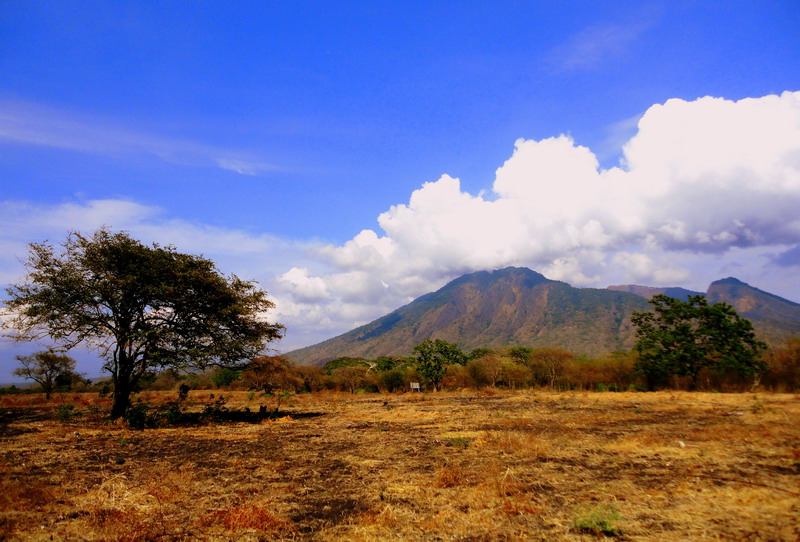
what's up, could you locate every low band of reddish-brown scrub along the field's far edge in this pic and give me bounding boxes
[12,339,800,398]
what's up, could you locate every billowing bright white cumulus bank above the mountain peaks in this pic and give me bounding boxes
[270,92,800,344]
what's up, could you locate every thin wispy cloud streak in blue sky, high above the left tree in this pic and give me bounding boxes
[0,100,281,176]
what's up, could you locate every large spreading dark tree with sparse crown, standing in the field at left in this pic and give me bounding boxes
[6,228,283,418]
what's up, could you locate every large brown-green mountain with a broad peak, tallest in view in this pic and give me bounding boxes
[287,267,649,365]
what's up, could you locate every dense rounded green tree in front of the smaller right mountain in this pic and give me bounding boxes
[631,295,766,389]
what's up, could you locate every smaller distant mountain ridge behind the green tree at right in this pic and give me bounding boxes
[608,277,800,345]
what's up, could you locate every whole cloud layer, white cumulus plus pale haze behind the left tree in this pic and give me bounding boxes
[0,92,800,366]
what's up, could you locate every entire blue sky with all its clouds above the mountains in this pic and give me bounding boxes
[0,1,800,380]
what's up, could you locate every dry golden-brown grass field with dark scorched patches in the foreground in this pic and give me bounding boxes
[0,390,800,541]
